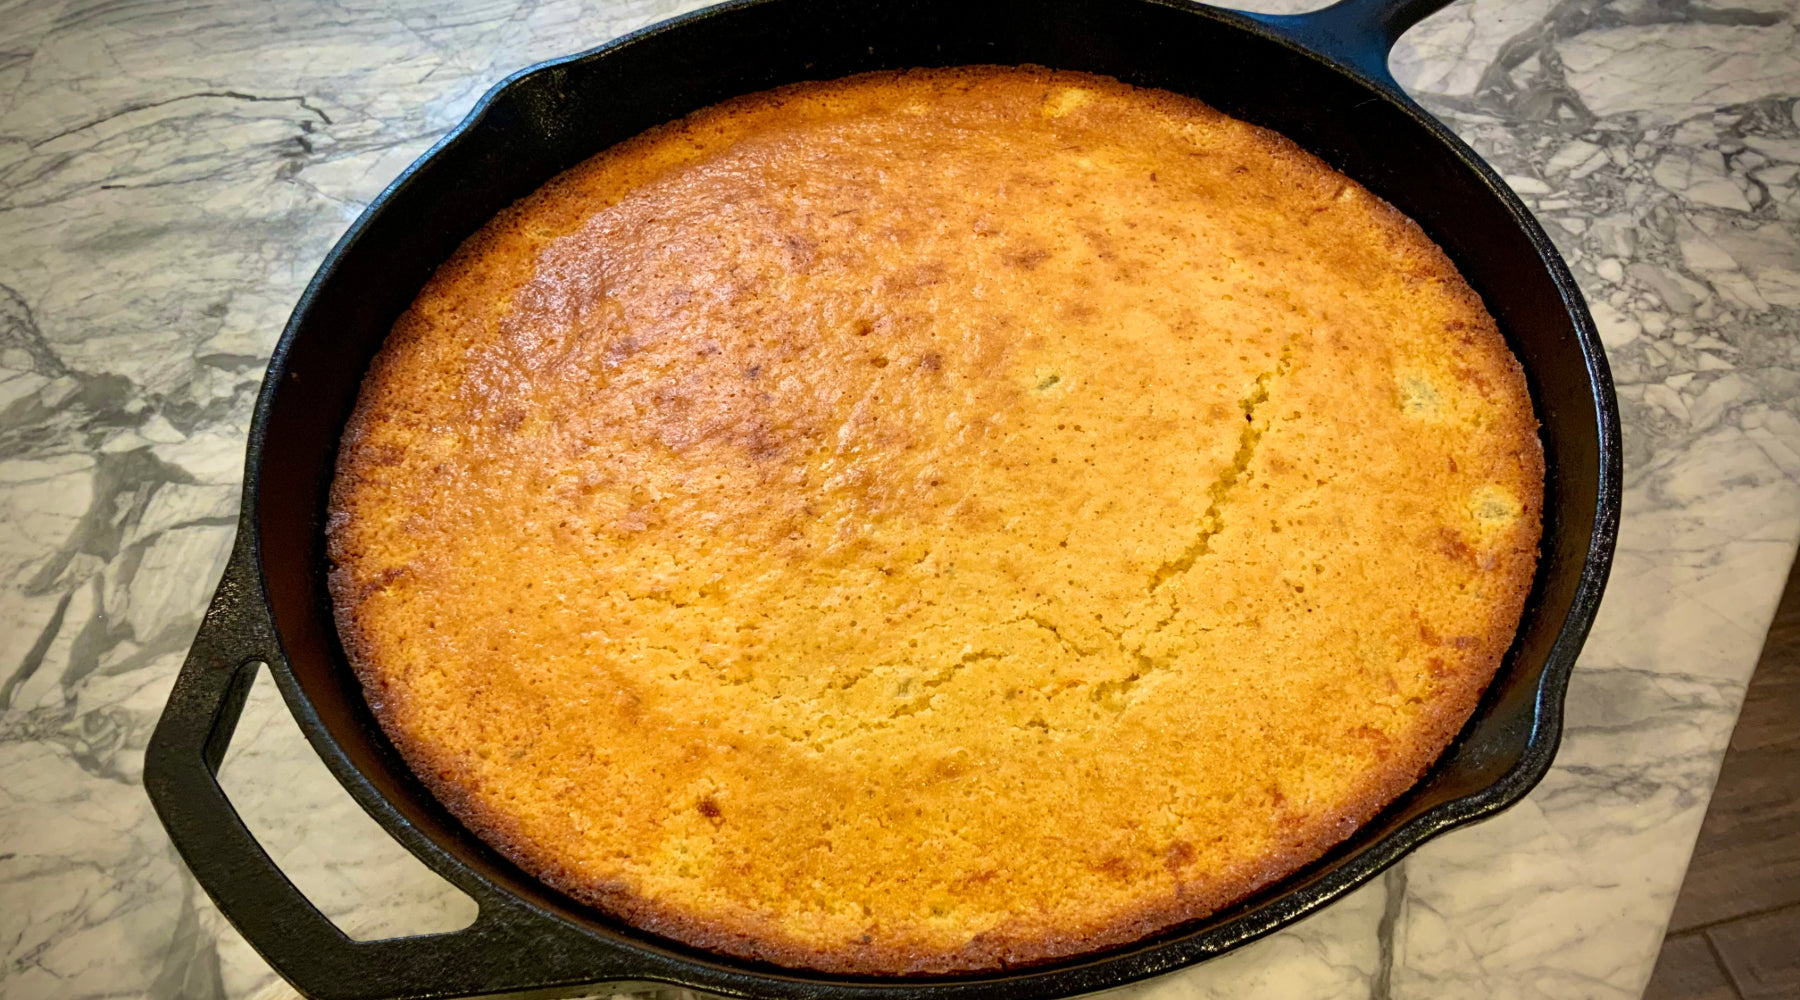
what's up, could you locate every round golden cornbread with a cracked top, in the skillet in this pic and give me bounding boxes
[328,68,1543,973]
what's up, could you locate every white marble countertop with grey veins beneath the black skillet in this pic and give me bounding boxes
[0,0,1800,1000]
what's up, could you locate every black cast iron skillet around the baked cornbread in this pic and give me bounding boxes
[144,0,1620,1000]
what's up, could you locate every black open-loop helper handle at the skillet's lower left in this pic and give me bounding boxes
[144,531,632,1000]
